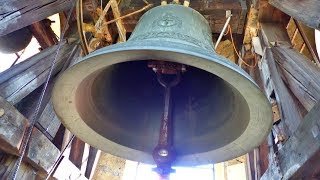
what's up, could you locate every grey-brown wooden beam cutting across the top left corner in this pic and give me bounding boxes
[0,0,72,36]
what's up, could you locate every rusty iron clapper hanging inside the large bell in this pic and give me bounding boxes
[148,61,186,179]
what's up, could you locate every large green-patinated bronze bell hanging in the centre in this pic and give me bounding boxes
[52,5,272,166]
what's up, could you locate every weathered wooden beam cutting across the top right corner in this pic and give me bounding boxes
[269,0,320,30]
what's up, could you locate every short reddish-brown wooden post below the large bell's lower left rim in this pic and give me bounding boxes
[69,137,85,169]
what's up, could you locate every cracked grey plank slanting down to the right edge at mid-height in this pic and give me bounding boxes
[271,45,320,111]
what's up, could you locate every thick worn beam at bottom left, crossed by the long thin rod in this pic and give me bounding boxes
[0,97,60,177]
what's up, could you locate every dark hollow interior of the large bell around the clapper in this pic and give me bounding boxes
[75,60,250,156]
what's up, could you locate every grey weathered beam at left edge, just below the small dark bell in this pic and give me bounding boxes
[0,42,75,104]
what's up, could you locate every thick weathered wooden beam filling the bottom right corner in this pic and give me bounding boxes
[261,102,320,180]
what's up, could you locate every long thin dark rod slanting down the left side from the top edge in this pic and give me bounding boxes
[12,0,76,180]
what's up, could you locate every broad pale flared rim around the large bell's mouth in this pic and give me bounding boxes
[52,40,272,166]
